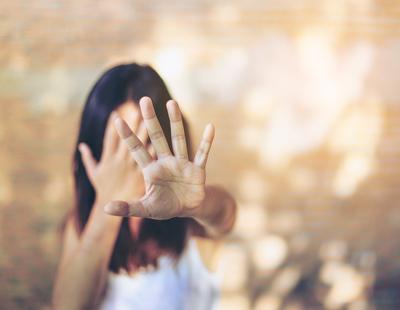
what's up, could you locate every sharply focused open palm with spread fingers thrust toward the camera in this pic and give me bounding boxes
[105,97,214,219]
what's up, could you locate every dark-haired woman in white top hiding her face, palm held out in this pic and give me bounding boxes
[53,64,236,310]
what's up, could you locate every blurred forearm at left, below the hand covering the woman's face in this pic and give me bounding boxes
[54,204,122,309]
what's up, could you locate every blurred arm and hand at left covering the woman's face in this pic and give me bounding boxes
[53,110,146,310]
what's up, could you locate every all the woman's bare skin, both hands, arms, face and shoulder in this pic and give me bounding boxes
[53,97,236,309]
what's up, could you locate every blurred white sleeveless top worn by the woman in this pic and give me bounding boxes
[99,239,219,310]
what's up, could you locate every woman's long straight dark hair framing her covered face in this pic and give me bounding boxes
[73,63,191,272]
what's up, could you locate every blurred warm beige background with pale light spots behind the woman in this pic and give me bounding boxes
[0,0,400,310]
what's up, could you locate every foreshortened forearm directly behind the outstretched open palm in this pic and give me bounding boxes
[190,186,237,237]
